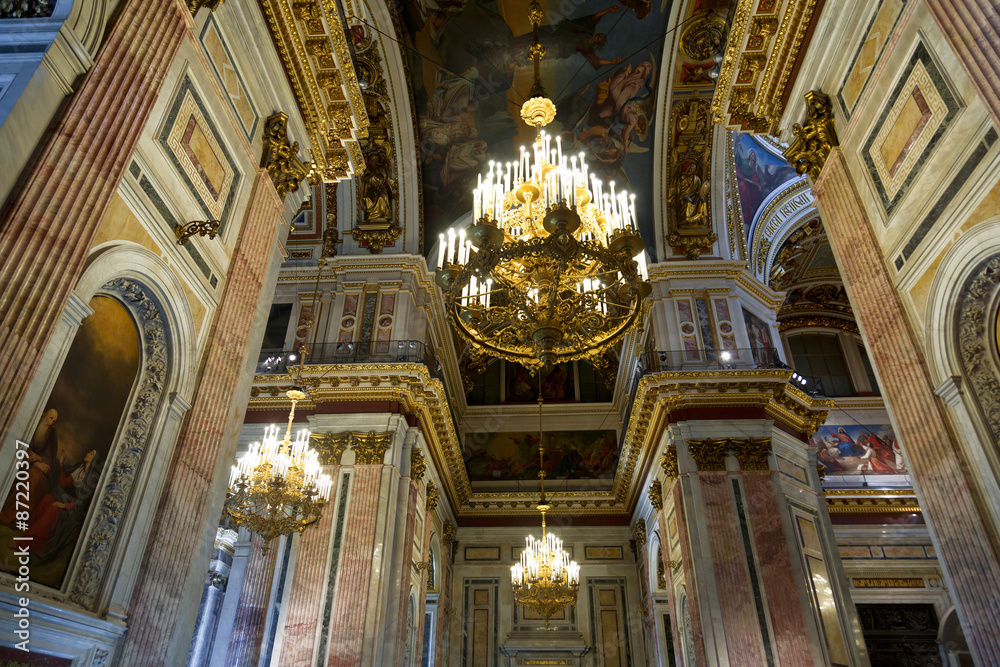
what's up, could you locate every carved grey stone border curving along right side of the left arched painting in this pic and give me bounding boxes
[69,278,168,609]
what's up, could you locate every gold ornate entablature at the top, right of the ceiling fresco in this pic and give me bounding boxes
[712,0,816,134]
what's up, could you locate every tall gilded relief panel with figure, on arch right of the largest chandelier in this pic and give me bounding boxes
[667,99,717,259]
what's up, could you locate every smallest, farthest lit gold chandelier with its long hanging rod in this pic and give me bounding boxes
[510,377,580,627]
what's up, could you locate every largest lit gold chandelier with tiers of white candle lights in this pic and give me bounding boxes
[435,0,652,368]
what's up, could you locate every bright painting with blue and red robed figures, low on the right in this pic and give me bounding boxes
[810,424,907,475]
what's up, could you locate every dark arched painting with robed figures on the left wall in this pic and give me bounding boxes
[0,296,142,588]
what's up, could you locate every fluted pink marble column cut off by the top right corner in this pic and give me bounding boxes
[925,0,1000,127]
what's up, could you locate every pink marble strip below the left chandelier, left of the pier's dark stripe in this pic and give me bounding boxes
[280,466,340,665]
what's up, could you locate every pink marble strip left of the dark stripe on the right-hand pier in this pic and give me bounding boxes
[698,472,768,667]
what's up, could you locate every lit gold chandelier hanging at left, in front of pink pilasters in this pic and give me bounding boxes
[225,388,333,549]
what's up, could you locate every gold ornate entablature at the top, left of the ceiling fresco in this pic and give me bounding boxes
[260,0,368,182]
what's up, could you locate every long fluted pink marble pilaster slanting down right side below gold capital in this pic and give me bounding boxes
[813,149,1000,665]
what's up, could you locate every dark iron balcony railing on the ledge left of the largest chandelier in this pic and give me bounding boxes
[257,340,440,376]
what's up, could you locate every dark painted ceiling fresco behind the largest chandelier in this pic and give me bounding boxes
[398,0,672,252]
